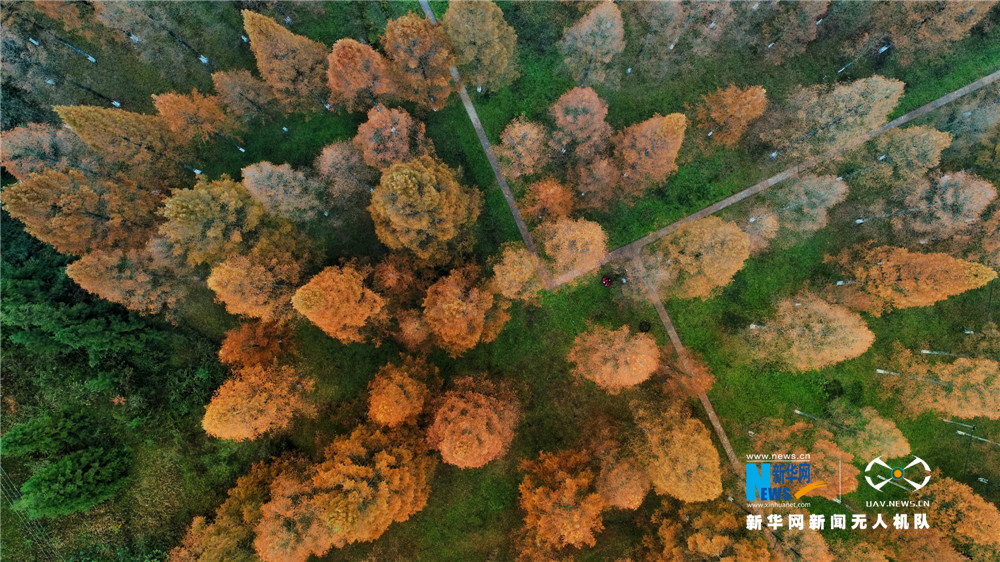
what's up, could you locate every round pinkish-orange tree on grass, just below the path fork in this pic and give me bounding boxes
[567,326,660,394]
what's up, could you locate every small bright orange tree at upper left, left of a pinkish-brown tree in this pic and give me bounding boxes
[153,89,237,143]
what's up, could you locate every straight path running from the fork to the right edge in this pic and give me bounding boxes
[549,70,1000,290]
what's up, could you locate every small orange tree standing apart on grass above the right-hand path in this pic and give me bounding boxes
[698,84,767,146]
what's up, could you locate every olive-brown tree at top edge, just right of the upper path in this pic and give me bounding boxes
[441,1,518,92]
